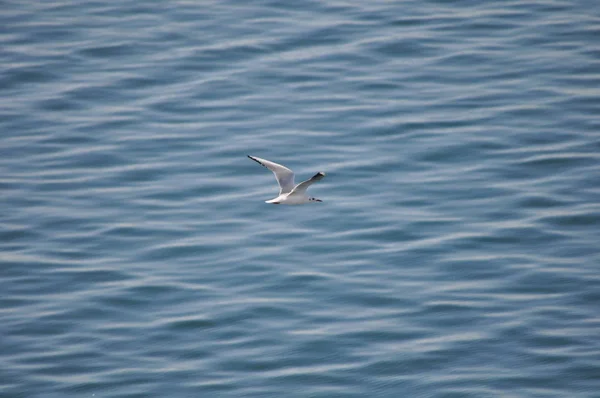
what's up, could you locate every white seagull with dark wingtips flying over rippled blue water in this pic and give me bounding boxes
[248,155,325,205]
